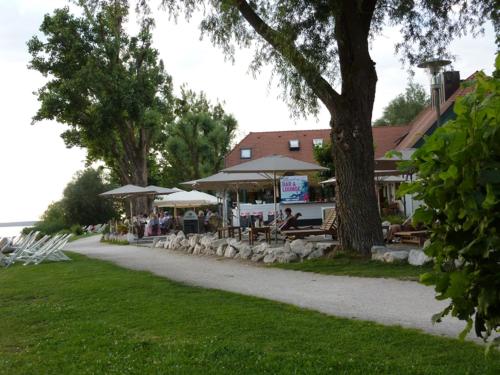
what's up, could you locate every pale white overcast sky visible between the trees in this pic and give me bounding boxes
[0,0,496,223]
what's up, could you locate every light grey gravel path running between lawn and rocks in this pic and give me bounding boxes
[67,236,464,337]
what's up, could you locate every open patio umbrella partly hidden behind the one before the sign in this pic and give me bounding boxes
[181,172,270,227]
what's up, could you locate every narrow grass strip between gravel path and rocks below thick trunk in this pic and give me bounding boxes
[273,254,432,281]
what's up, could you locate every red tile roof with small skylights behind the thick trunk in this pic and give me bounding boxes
[225,125,409,168]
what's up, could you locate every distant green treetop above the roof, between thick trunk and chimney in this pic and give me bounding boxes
[373,82,429,126]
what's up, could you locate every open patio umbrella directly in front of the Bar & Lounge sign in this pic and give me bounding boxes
[222,155,328,241]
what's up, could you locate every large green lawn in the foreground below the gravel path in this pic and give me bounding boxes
[0,254,500,375]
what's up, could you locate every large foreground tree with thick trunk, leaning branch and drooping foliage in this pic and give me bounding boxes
[158,0,499,253]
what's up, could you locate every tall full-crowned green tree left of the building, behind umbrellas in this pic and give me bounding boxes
[28,0,173,213]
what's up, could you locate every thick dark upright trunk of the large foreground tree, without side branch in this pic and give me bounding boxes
[330,1,383,254]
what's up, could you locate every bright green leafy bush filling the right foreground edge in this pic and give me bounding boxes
[399,55,500,343]
